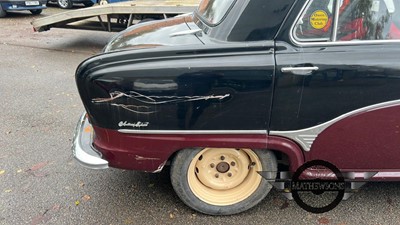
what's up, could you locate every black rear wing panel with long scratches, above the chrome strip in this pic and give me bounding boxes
[76,42,274,130]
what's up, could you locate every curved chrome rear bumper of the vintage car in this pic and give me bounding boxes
[72,113,108,169]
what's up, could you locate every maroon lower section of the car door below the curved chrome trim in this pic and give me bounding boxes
[305,106,400,171]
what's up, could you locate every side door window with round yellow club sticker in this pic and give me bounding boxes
[293,0,400,42]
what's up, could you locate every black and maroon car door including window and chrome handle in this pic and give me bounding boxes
[270,0,400,170]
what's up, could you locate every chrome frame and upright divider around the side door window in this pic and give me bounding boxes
[289,0,400,47]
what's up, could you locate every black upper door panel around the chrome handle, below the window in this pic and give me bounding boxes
[271,43,400,131]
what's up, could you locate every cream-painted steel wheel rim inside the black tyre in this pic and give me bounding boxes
[188,148,262,206]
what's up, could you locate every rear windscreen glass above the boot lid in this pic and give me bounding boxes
[197,0,236,25]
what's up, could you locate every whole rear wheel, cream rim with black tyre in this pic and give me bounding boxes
[171,148,277,215]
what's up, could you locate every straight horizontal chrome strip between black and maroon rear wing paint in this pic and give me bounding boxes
[118,129,268,135]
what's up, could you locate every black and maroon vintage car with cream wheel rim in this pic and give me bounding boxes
[73,0,400,215]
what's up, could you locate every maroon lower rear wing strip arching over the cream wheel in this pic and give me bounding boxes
[93,126,304,172]
